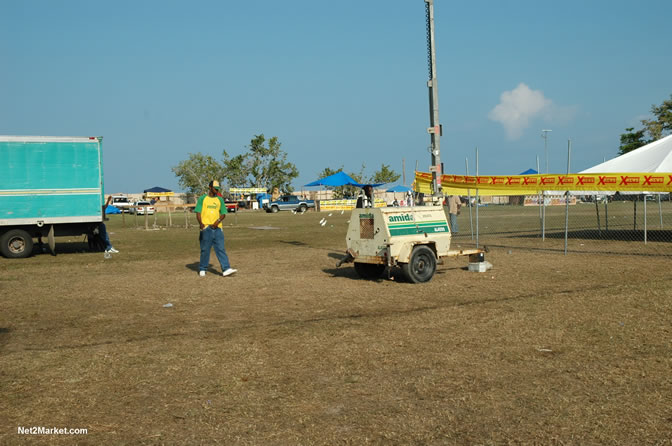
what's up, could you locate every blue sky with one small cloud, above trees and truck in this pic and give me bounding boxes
[0,0,672,193]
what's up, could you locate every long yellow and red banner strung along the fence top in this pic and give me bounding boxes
[415,172,672,195]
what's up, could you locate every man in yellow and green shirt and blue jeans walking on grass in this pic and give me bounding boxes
[194,180,238,277]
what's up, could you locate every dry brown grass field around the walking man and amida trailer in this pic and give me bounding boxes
[0,212,672,445]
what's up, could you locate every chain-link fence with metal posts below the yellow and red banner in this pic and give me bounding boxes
[454,194,672,256]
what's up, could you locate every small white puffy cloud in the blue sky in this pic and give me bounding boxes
[488,82,552,140]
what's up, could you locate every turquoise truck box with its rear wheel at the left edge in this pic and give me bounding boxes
[0,135,104,258]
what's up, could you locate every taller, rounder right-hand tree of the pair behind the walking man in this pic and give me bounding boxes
[247,134,299,192]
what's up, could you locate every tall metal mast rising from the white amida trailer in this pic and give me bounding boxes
[425,0,443,203]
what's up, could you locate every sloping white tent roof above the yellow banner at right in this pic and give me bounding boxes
[579,135,672,173]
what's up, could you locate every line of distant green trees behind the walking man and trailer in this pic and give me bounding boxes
[172,133,401,198]
